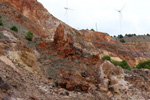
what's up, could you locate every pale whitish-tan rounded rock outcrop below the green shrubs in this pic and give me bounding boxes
[99,61,128,94]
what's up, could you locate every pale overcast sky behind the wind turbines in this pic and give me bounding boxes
[38,0,150,36]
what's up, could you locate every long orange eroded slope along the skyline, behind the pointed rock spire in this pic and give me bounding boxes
[0,0,150,66]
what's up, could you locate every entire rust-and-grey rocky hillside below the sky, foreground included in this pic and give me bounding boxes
[0,0,150,100]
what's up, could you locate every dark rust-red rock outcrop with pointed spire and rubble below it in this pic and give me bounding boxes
[49,24,100,92]
